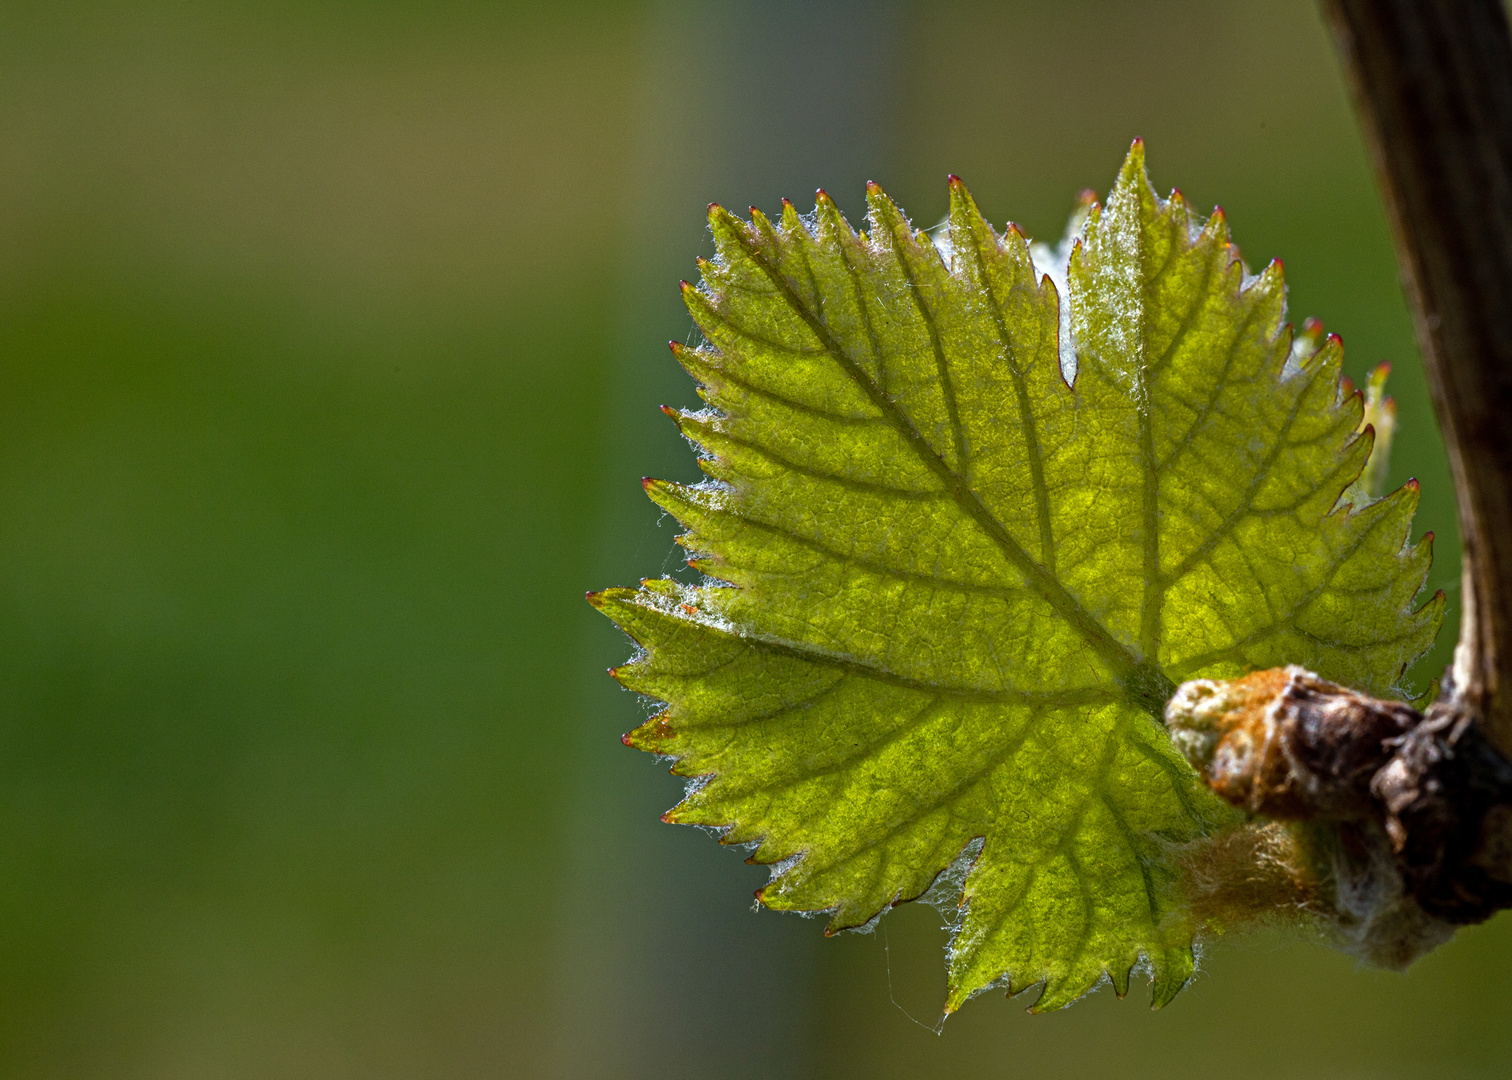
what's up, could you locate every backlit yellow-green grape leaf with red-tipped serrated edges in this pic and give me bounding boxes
[591,144,1442,1009]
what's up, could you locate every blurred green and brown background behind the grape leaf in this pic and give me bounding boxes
[0,0,1512,1080]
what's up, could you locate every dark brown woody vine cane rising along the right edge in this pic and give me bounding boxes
[1321,0,1512,756]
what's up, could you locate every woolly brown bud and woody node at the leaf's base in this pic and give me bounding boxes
[1166,667,1512,967]
